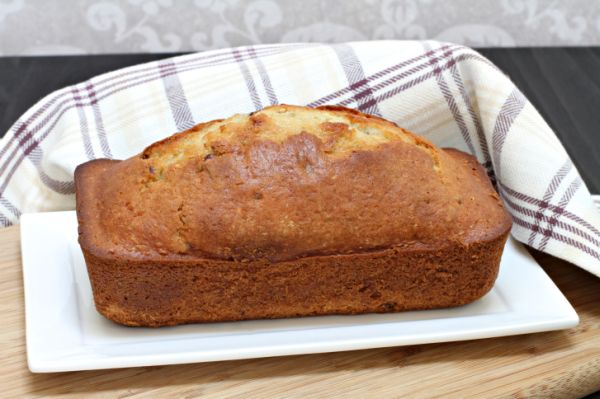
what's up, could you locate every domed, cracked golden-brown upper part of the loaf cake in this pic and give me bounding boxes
[75,105,511,262]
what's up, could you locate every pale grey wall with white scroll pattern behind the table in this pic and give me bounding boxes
[0,0,600,55]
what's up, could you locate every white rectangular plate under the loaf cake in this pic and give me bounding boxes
[21,211,579,372]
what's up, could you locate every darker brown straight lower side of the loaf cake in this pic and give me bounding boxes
[84,234,508,327]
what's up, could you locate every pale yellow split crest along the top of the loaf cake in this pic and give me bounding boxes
[141,104,438,168]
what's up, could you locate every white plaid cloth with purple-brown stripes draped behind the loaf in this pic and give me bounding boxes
[0,41,600,276]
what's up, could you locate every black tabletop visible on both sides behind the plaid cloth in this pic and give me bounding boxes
[0,47,600,193]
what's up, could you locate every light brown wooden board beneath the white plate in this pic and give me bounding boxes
[0,227,600,398]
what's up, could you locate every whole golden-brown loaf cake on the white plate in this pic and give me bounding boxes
[75,105,511,327]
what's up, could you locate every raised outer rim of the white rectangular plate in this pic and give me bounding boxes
[20,211,579,373]
